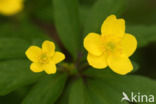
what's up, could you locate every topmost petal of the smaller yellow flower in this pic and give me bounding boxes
[42,40,55,55]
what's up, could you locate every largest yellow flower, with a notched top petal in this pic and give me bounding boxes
[84,15,137,75]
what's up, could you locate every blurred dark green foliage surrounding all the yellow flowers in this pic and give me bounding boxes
[0,0,156,104]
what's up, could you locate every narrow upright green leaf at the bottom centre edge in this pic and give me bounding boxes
[69,79,86,104]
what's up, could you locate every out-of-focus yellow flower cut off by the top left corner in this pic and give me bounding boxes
[0,0,23,16]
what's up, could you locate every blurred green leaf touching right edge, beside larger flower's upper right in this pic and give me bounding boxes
[127,25,156,47]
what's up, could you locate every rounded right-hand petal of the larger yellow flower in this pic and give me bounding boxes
[121,34,137,57]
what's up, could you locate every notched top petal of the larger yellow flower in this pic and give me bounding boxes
[101,15,125,37]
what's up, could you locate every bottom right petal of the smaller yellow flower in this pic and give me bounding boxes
[44,62,56,74]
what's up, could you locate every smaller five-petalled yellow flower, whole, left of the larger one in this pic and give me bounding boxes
[26,40,65,74]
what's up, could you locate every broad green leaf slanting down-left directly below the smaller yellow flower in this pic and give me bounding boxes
[22,74,67,104]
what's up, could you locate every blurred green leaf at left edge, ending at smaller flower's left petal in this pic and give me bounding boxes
[0,38,29,60]
